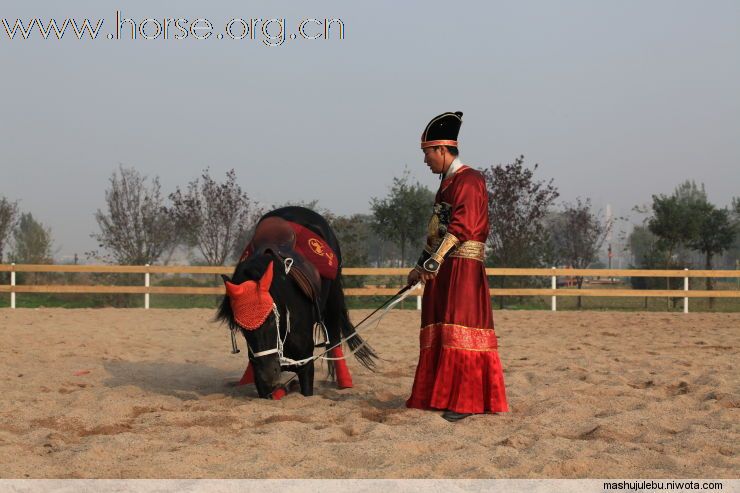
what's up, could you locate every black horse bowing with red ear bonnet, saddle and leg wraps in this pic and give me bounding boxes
[216,207,377,398]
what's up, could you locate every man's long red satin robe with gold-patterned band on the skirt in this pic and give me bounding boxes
[406,166,509,413]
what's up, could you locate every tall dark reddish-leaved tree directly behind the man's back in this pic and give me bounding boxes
[484,156,559,308]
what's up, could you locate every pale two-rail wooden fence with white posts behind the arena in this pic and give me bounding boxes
[0,264,740,313]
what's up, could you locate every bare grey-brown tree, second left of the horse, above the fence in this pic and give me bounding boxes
[90,166,177,265]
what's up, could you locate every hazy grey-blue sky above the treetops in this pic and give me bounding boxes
[0,0,740,259]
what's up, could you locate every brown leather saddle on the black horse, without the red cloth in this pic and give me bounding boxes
[250,216,321,303]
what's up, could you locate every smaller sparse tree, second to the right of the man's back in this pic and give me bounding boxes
[548,198,614,308]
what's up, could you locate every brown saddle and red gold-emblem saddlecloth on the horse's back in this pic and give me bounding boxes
[240,216,337,301]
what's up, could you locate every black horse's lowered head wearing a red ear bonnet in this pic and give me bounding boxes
[218,254,285,389]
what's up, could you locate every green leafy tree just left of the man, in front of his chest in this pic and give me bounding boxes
[370,170,434,266]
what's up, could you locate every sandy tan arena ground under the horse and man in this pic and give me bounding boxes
[0,309,740,478]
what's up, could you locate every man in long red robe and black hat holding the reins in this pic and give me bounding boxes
[406,112,509,421]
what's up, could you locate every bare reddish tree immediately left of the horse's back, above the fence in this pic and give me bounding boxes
[170,169,262,265]
